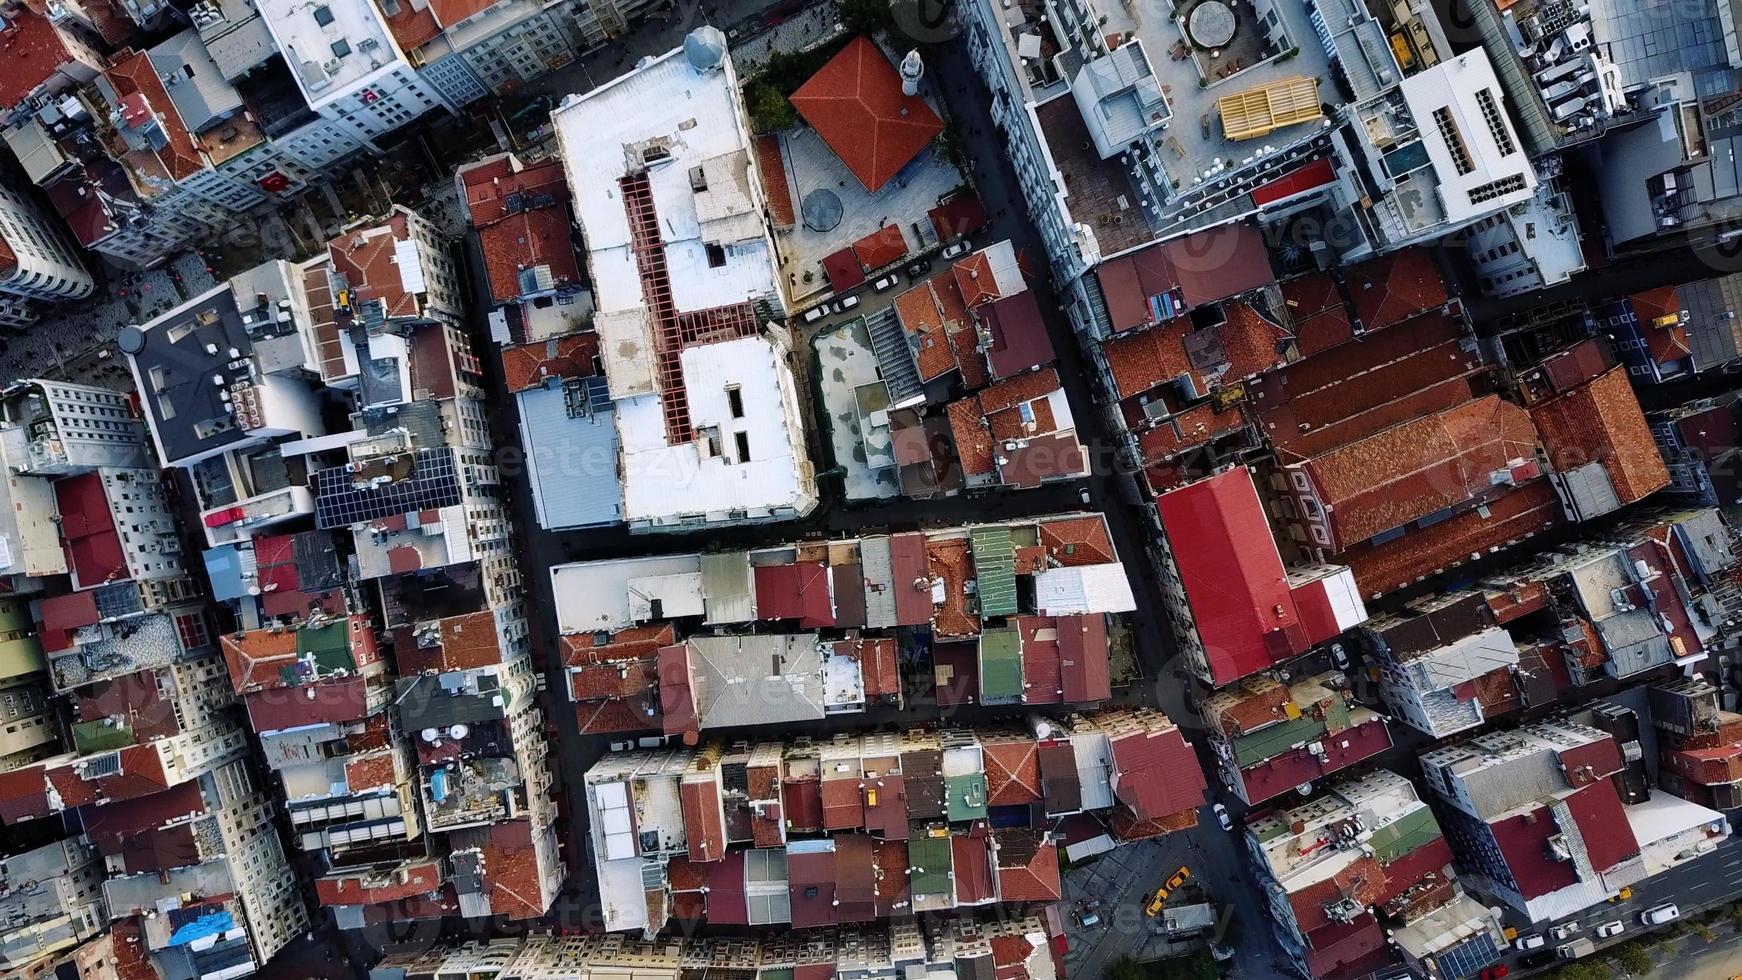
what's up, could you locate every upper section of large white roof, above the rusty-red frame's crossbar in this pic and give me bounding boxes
[550,49,779,313]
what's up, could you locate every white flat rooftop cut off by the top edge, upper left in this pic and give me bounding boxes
[256,0,404,106]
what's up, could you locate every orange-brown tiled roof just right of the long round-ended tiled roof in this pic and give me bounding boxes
[1529,367,1669,505]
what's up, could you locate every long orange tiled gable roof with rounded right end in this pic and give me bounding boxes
[1303,396,1539,550]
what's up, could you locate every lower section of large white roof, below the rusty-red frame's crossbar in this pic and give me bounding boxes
[617,338,810,522]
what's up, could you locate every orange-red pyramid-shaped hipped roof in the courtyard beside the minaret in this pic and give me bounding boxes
[791,37,944,191]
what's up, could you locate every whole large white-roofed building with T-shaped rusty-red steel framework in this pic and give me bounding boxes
[543,28,817,531]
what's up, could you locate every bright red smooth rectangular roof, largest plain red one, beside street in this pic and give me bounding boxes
[1155,467,1307,686]
